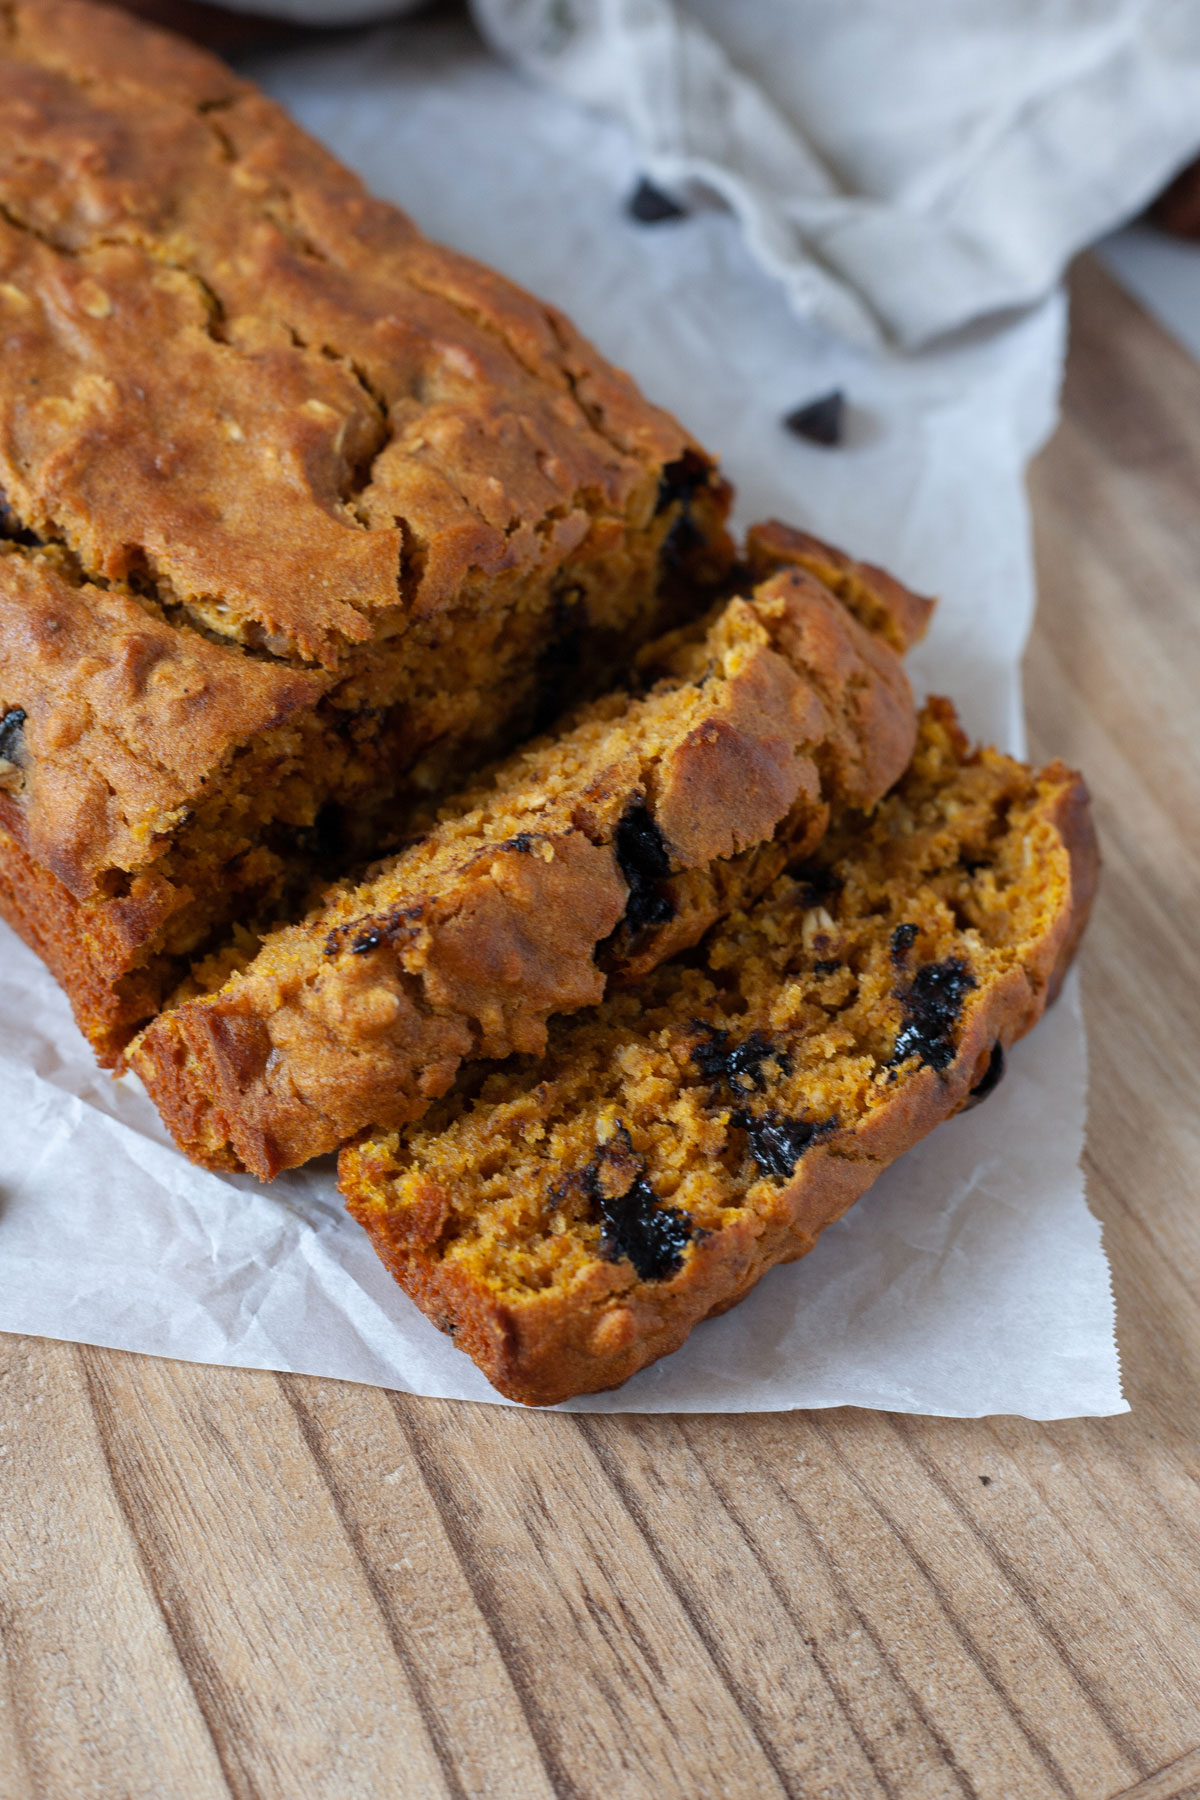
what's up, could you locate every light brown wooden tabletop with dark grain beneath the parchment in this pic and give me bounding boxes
[0,263,1200,1800]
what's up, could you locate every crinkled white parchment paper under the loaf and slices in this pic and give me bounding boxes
[0,20,1124,1418]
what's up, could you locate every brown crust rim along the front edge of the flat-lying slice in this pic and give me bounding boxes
[340,716,1099,1406]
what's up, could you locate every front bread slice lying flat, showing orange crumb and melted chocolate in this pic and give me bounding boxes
[340,702,1097,1406]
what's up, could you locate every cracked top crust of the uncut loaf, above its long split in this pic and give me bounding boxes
[0,0,694,668]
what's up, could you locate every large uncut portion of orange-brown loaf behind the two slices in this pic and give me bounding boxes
[0,0,732,1062]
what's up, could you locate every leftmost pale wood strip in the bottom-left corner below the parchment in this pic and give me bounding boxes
[0,1336,230,1800]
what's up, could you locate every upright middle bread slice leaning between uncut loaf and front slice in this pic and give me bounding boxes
[130,567,916,1179]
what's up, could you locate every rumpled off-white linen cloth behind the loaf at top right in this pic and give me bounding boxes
[239,0,1200,349]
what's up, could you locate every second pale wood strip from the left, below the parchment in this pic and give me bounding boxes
[79,1350,462,1800]
